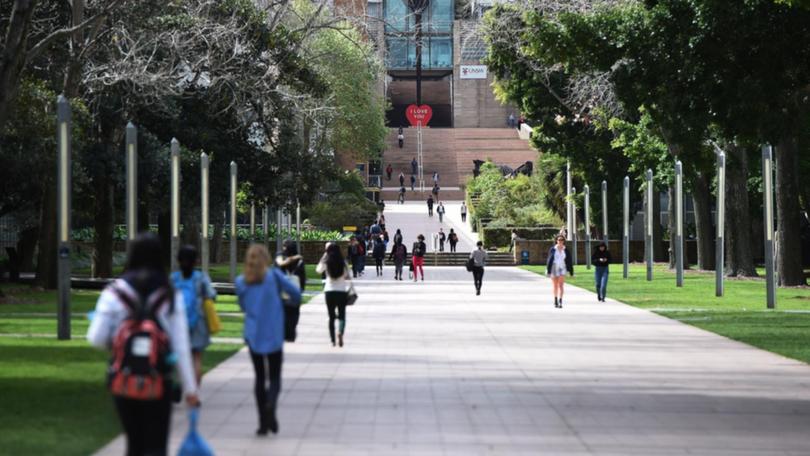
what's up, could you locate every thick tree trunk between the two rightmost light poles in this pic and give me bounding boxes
[725,143,757,277]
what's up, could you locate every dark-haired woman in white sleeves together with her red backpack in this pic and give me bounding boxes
[87,234,200,455]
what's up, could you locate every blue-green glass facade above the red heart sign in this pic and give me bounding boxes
[384,0,455,70]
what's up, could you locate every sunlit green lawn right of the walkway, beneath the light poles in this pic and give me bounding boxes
[524,264,810,363]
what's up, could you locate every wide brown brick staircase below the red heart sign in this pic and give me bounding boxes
[382,128,537,201]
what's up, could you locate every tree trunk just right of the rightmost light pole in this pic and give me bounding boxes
[775,137,806,286]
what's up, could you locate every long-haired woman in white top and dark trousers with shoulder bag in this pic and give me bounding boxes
[315,242,351,347]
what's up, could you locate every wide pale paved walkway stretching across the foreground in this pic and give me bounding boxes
[100,267,810,456]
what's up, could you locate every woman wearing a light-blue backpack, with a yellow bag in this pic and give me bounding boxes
[171,245,217,384]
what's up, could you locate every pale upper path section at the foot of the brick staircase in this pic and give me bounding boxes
[385,201,478,252]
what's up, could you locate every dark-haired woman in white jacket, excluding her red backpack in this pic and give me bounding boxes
[87,234,199,455]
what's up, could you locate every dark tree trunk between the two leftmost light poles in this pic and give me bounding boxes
[93,174,115,279]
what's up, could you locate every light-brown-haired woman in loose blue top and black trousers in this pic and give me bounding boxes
[235,244,301,435]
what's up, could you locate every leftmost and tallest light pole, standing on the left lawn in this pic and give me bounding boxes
[56,95,72,340]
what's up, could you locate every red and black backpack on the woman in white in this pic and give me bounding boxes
[107,285,174,401]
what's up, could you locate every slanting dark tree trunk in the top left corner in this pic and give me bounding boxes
[0,0,37,131]
